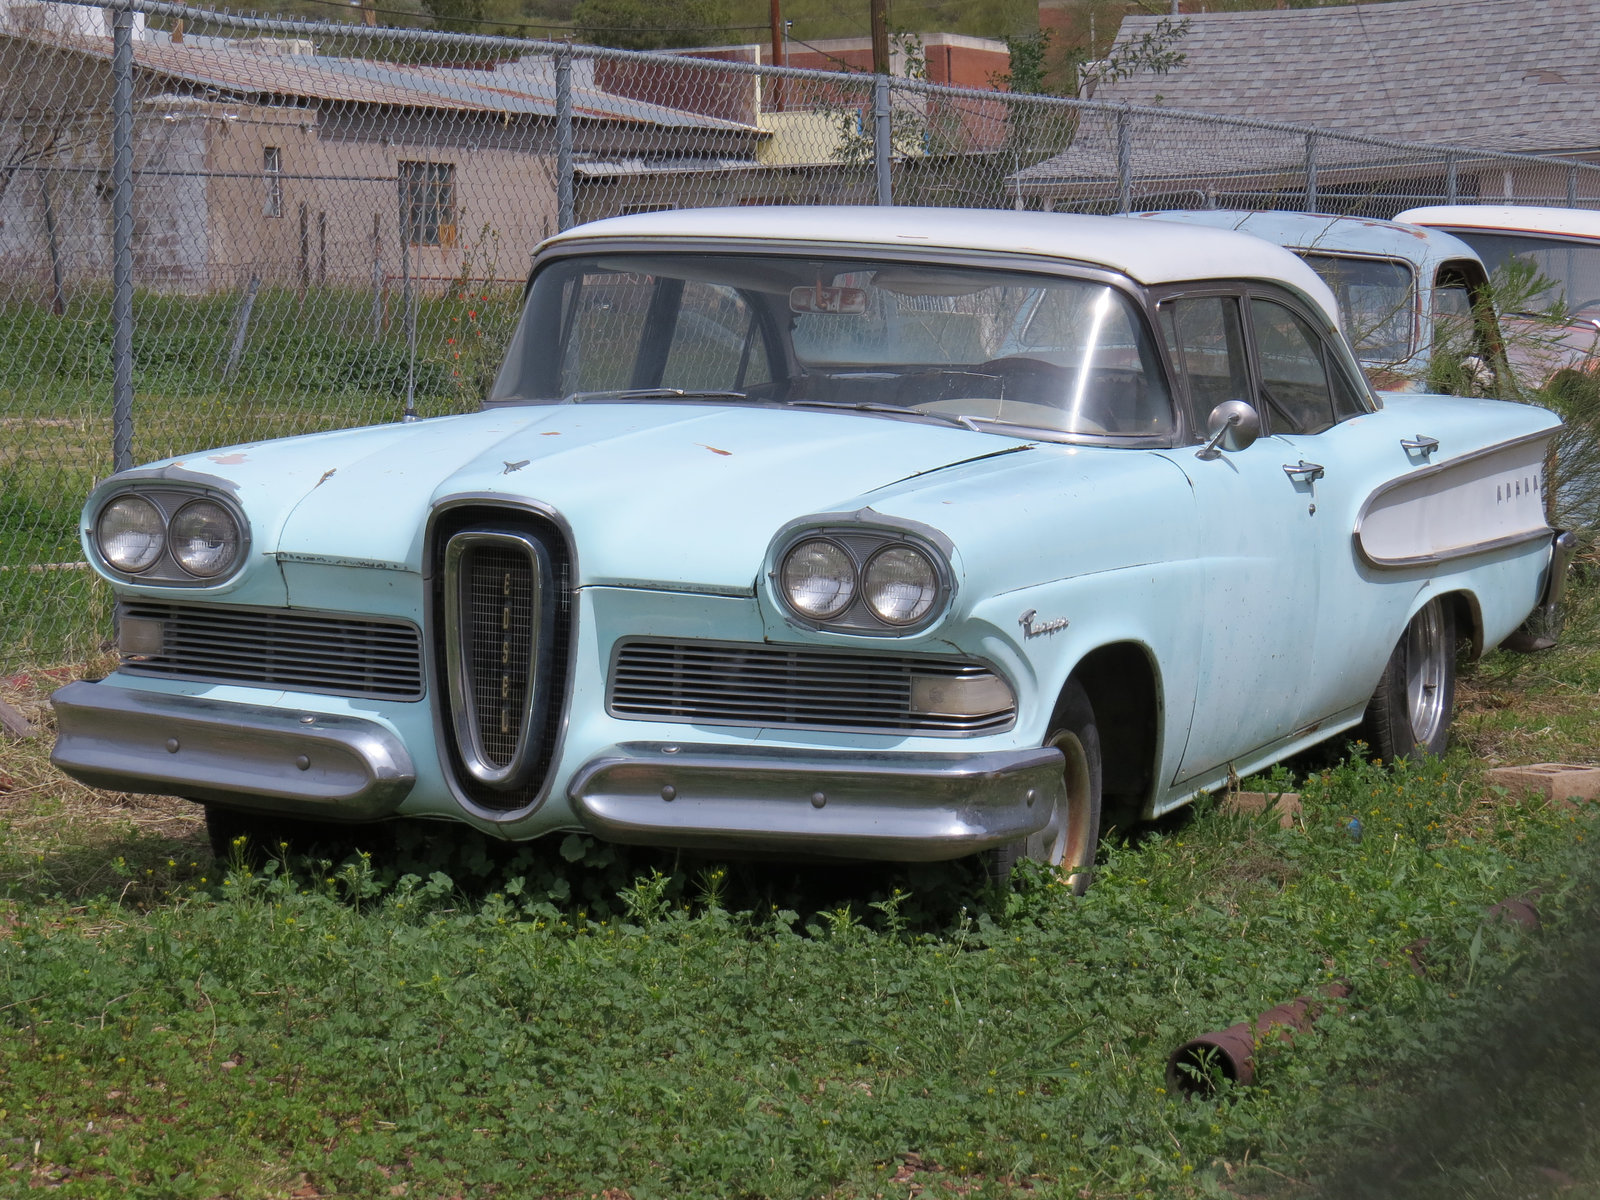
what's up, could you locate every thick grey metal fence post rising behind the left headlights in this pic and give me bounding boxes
[110,6,133,470]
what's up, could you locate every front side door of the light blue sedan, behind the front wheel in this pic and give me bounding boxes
[1157,290,1320,782]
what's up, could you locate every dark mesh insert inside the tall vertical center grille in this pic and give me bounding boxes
[464,547,534,766]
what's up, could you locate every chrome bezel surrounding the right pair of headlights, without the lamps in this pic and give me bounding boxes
[766,514,955,637]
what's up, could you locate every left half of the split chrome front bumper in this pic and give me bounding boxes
[50,683,416,821]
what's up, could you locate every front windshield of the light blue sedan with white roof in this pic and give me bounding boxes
[490,253,1173,437]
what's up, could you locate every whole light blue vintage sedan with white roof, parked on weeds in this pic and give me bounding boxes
[54,208,1563,886]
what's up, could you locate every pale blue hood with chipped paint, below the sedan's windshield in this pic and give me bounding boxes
[262,402,1029,590]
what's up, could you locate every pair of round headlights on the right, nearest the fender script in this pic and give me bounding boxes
[771,528,954,635]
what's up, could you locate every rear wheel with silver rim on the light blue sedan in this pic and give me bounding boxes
[1360,597,1456,762]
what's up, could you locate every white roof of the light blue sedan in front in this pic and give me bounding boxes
[544,205,1339,328]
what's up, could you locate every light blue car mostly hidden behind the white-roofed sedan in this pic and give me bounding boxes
[1133,208,1512,395]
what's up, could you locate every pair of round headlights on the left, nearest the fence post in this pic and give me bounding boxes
[90,488,248,586]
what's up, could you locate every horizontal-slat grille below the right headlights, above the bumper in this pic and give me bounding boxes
[608,642,1014,734]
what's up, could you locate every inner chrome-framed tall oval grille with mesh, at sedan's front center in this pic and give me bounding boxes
[443,530,555,792]
